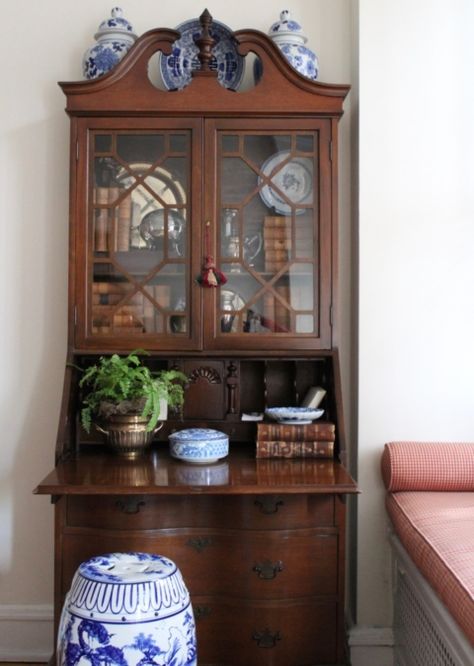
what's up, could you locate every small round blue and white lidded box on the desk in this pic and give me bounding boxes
[169,428,229,465]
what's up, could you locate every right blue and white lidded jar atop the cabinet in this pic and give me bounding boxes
[268,9,319,81]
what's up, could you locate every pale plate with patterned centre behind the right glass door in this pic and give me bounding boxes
[259,150,313,215]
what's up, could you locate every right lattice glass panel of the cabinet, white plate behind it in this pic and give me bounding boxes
[207,121,331,348]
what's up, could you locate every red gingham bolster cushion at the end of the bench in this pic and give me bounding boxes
[382,442,474,492]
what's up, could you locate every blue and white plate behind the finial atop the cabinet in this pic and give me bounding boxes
[160,19,245,90]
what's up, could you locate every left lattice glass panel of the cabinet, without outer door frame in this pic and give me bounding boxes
[77,124,199,348]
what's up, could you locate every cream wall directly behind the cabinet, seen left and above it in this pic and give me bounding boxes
[0,0,351,660]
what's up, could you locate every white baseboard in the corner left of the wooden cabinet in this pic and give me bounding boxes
[0,604,53,663]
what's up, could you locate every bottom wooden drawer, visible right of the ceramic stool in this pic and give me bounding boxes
[193,597,342,666]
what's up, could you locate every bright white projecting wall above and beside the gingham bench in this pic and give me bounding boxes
[354,0,474,666]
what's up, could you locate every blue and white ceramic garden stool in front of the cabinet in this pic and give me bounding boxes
[57,553,197,666]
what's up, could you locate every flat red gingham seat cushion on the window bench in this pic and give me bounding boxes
[386,492,474,645]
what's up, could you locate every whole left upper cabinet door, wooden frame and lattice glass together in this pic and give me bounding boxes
[73,118,202,350]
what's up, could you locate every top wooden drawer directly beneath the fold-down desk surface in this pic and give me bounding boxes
[66,494,335,530]
